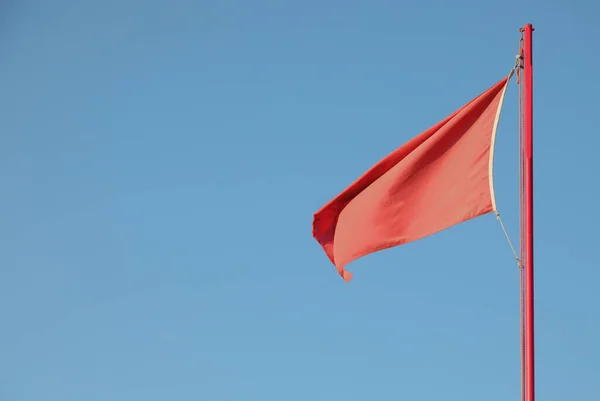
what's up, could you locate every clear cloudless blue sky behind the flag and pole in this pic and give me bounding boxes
[0,0,600,401]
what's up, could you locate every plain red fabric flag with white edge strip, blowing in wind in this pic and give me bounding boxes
[313,76,510,281]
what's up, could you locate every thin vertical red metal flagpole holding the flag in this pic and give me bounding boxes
[523,24,535,401]
